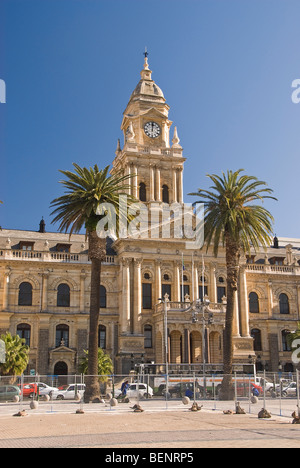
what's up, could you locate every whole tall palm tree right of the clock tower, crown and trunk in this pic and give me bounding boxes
[190,169,276,399]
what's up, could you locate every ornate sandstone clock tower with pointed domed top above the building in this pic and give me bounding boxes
[113,52,185,204]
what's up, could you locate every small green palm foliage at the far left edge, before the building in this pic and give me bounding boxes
[0,332,29,376]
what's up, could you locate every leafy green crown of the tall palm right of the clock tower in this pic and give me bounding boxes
[190,169,276,255]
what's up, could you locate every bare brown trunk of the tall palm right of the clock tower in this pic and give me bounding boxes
[220,234,240,400]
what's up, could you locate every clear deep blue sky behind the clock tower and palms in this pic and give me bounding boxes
[0,0,300,237]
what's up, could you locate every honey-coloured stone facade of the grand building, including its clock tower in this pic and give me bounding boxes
[0,58,300,374]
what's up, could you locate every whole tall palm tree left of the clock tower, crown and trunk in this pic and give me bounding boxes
[51,164,133,402]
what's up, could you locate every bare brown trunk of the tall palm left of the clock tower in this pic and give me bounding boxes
[84,231,106,403]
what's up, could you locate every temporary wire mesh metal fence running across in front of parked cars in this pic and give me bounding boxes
[0,371,300,416]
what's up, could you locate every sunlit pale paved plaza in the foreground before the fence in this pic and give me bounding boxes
[0,401,300,449]
